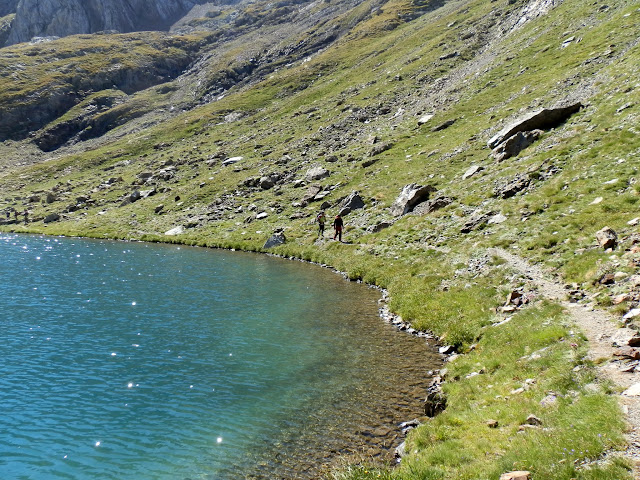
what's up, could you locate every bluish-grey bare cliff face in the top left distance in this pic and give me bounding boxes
[0,0,201,45]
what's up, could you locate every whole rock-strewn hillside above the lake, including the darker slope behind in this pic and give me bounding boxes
[0,0,640,480]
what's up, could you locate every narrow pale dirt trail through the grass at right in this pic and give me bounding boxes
[489,248,640,479]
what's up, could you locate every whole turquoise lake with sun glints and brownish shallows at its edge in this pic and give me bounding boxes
[0,234,438,479]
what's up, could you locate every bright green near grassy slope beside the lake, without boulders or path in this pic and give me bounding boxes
[0,0,640,479]
